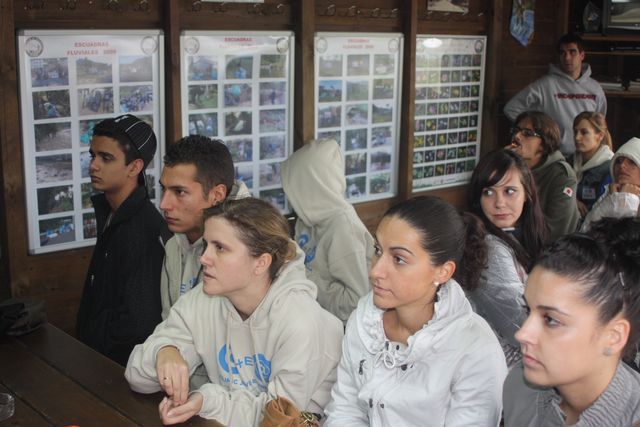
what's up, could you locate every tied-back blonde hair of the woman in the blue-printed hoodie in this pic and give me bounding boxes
[203,197,296,281]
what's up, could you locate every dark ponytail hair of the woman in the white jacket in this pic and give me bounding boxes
[384,196,487,291]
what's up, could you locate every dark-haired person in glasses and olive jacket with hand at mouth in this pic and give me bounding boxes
[508,111,580,242]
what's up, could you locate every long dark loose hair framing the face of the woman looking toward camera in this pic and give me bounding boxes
[468,149,547,272]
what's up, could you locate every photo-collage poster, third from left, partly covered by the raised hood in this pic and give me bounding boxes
[314,33,403,203]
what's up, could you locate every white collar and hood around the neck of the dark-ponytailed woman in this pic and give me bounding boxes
[356,279,473,366]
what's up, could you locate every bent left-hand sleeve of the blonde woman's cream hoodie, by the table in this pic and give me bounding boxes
[124,310,202,393]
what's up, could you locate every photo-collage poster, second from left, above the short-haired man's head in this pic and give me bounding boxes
[180,31,294,212]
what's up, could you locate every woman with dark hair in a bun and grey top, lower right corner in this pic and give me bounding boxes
[504,218,640,427]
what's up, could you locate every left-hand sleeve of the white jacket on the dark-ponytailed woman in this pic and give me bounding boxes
[324,312,369,427]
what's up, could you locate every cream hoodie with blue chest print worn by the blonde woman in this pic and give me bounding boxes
[125,250,343,427]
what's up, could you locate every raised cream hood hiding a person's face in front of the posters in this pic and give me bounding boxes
[281,139,351,227]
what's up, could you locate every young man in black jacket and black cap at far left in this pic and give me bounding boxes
[76,114,171,365]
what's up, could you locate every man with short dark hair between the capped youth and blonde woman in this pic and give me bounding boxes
[160,135,251,319]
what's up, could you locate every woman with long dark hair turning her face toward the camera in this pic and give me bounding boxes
[467,149,546,367]
